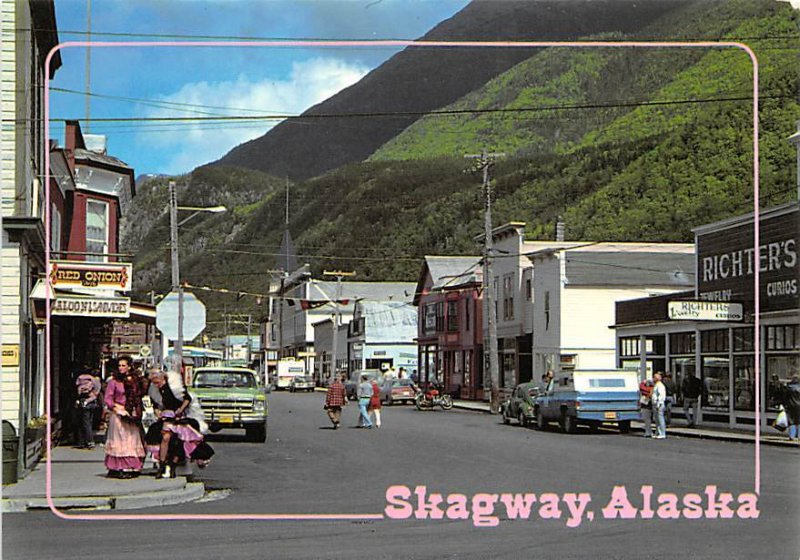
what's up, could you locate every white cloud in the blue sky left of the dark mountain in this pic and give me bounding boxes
[138,58,369,174]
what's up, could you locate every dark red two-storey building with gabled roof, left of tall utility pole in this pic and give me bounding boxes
[414,256,484,400]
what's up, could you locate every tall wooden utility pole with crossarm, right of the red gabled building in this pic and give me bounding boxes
[464,150,505,414]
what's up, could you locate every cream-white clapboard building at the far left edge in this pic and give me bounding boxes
[0,0,61,472]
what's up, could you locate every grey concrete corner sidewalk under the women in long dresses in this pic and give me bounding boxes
[2,445,205,513]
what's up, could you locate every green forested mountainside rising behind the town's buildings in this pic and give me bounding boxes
[124,0,800,333]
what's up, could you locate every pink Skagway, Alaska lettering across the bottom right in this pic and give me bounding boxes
[384,485,759,528]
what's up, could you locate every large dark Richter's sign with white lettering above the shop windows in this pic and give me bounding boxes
[697,204,800,311]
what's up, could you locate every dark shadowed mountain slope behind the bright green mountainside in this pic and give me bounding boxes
[211,0,692,180]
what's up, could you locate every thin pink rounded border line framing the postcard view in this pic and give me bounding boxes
[44,41,761,521]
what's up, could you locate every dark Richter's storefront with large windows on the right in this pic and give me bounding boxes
[615,202,800,429]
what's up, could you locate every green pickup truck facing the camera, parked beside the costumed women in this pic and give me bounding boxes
[192,366,267,443]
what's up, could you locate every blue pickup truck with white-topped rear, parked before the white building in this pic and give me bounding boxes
[534,370,639,433]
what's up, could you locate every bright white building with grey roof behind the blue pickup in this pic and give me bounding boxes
[528,242,695,379]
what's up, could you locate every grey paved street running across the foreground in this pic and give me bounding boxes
[3,393,800,559]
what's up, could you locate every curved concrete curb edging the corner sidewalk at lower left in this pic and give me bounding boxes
[2,482,205,513]
